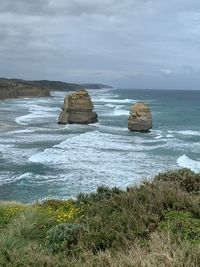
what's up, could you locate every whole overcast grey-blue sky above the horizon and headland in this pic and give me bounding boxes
[0,0,200,89]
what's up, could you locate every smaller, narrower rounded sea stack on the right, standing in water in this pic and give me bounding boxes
[128,102,152,132]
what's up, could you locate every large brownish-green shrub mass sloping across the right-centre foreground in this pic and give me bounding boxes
[78,183,199,252]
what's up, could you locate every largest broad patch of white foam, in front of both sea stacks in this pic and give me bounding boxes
[29,131,165,191]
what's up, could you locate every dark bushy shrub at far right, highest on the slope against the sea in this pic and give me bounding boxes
[154,168,200,194]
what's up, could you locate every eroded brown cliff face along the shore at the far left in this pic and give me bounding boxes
[0,82,50,99]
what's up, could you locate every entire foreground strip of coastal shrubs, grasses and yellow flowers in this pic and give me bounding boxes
[0,169,200,267]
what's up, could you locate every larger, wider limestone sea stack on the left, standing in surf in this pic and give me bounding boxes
[58,90,98,124]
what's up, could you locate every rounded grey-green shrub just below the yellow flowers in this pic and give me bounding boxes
[47,223,83,254]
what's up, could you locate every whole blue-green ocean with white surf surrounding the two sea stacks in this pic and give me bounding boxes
[0,89,200,202]
